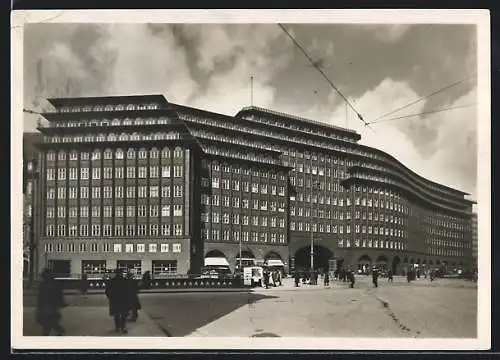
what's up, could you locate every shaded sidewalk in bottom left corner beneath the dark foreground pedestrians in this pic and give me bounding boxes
[23,306,169,336]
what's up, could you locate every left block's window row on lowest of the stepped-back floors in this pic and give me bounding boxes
[44,131,181,143]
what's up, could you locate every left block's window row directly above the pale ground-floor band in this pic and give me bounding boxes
[45,224,184,237]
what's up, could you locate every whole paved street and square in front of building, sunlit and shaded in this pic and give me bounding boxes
[24,277,477,338]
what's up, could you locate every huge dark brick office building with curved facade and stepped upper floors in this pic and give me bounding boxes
[33,95,472,276]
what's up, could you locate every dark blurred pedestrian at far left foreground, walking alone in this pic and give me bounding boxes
[36,269,66,336]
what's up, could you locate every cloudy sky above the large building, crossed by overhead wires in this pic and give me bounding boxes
[24,24,477,198]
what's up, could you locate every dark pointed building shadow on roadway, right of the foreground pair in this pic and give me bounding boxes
[139,292,278,337]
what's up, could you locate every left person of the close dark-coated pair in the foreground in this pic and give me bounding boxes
[106,270,133,334]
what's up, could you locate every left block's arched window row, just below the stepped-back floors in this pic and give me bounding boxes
[46,147,184,161]
